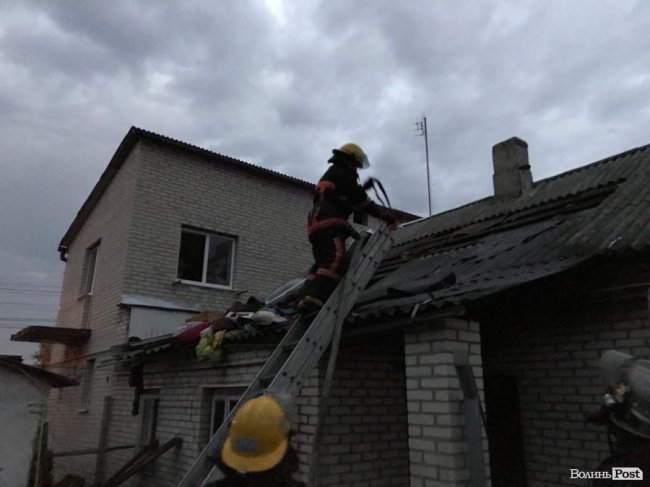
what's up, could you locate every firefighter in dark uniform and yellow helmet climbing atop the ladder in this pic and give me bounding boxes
[297,143,399,313]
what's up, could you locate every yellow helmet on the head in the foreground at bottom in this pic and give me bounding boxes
[221,396,290,472]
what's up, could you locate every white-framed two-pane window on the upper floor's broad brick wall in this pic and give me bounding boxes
[178,229,235,288]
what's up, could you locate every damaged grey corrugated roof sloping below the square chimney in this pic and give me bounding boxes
[352,140,650,319]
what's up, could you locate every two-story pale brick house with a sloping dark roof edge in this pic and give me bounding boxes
[14,128,324,482]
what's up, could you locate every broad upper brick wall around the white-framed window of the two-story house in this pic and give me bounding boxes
[123,142,312,310]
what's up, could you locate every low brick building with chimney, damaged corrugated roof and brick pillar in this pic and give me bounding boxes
[348,138,650,487]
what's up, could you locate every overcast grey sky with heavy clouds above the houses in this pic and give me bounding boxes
[0,0,650,354]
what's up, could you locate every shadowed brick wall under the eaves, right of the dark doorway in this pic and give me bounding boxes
[478,299,650,487]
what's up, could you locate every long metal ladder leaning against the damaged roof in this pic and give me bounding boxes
[178,224,393,487]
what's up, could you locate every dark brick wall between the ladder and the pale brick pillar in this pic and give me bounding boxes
[296,335,408,487]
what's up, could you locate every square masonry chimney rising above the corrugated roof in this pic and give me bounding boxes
[492,137,533,199]
